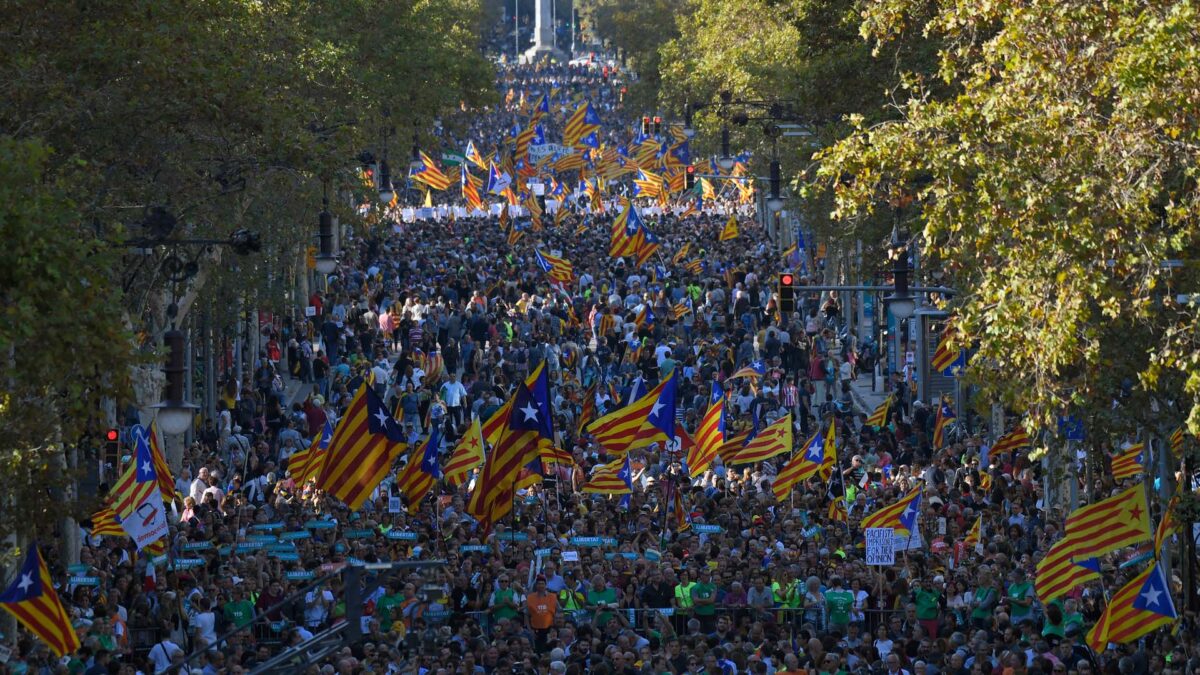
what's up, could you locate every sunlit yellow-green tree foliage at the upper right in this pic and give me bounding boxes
[820,0,1200,441]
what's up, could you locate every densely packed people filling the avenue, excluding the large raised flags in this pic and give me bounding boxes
[7,39,1200,675]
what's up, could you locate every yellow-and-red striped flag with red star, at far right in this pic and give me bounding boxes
[1067,483,1151,560]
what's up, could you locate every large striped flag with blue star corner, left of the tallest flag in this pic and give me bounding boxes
[317,382,404,510]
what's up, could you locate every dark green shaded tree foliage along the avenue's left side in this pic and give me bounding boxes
[0,0,494,536]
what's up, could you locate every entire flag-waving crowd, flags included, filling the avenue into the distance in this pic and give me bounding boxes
[0,31,1200,675]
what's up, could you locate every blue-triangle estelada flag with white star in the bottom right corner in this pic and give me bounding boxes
[1087,561,1178,653]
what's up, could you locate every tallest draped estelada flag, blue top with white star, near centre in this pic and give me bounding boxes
[467,362,554,525]
